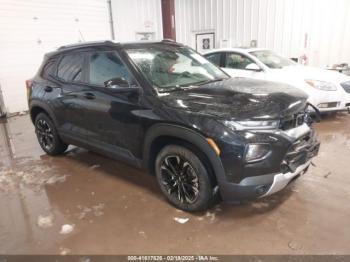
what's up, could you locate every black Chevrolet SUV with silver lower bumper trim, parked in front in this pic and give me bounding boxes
[26,41,319,211]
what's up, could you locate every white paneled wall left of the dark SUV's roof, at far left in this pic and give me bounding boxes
[0,0,111,112]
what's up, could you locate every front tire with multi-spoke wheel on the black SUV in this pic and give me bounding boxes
[155,145,214,212]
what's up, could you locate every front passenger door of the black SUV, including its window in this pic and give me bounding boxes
[80,51,143,158]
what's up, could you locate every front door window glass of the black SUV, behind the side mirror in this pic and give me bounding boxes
[89,52,131,86]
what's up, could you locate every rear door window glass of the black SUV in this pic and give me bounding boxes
[57,54,84,82]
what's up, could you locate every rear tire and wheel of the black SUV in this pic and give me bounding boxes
[35,113,68,156]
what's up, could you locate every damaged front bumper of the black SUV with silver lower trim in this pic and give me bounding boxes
[218,124,320,202]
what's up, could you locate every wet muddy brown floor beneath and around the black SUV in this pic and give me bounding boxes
[0,114,350,254]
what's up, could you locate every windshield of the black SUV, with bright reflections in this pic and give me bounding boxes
[126,47,228,92]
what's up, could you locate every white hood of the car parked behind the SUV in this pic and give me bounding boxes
[271,65,350,84]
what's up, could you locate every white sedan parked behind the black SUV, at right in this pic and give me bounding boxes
[204,48,350,112]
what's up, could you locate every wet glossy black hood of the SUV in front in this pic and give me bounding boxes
[160,78,307,120]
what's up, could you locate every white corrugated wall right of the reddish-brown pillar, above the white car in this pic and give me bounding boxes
[175,0,350,66]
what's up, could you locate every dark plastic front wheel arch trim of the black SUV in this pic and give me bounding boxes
[143,124,225,185]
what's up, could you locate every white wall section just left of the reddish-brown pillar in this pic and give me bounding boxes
[112,0,163,42]
